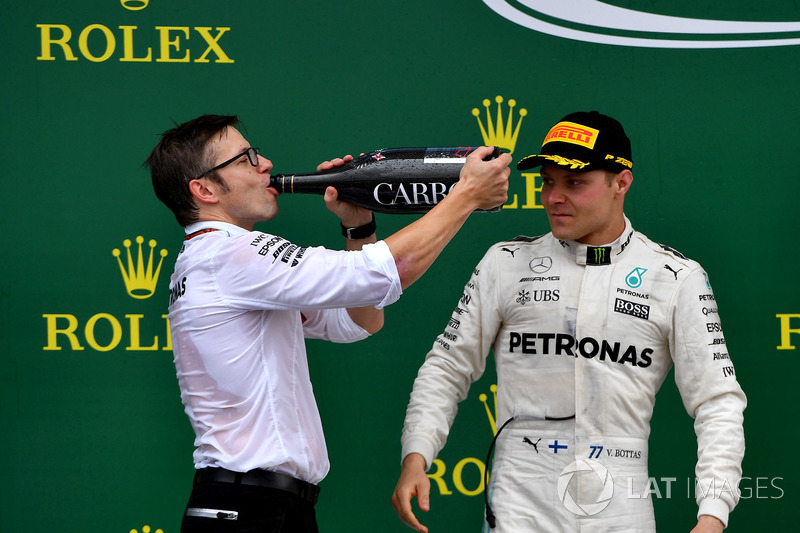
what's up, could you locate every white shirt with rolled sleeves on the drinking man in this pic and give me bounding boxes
[169,222,402,483]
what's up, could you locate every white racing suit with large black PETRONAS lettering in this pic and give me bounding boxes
[402,219,746,533]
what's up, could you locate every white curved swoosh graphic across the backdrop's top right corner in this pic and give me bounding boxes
[483,0,800,49]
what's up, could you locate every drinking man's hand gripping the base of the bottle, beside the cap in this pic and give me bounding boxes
[454,146,511,209]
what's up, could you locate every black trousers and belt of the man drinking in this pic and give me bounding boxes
[181,472,319,533]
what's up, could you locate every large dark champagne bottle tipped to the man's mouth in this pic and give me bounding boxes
[270,146,502,214]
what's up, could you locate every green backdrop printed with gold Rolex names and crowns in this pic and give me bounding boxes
[0,0,800,533]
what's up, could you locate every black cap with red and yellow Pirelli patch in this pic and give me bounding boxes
[517,111,633,172]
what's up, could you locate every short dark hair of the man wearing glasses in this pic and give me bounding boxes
[144,115,239,226]
